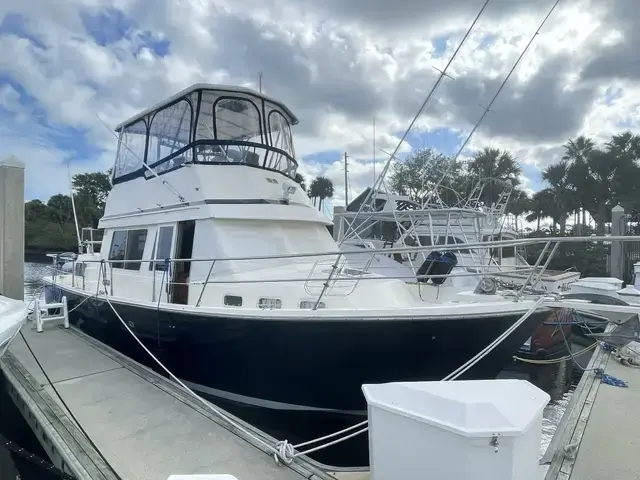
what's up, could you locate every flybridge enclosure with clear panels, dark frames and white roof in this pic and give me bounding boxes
[113,84,298,185]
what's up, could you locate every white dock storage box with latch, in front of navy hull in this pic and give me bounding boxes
[362,380,550,480]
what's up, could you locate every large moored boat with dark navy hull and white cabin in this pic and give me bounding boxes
[43,84,549,466]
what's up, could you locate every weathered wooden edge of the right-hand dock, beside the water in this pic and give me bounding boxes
[540,338,610,480]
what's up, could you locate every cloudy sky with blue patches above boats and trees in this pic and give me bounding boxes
[0,0,640,212]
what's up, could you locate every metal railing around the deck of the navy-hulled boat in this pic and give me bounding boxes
[51,236,640,308]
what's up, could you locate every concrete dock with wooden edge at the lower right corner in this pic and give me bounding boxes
[543,336,640,480]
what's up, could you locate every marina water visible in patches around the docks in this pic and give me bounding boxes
[0,257,591,474]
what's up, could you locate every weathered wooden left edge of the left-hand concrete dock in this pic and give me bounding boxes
[0,351,119,480]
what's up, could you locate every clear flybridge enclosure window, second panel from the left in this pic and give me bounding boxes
[145,100,193,178]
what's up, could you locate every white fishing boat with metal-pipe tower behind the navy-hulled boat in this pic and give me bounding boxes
[334,186,580,359]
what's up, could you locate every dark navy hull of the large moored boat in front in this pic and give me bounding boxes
[47,287,549,466]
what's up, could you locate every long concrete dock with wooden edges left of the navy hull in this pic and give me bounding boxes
[1,322,340,480]
